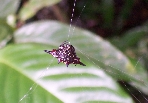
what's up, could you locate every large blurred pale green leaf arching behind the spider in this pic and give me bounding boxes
[15,21,148,93]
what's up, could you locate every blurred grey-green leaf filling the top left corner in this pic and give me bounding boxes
[0,0,20,18]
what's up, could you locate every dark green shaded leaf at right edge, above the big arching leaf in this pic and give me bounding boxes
[111,23,148,51]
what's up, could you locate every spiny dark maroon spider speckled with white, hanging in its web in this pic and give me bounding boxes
[44,41,86,67]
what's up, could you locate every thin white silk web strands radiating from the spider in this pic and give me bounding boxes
[18,0,148,103]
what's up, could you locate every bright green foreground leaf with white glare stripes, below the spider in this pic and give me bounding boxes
[0,43,133,103]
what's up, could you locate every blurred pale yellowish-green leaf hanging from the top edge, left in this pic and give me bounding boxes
[19,0,61,20]
